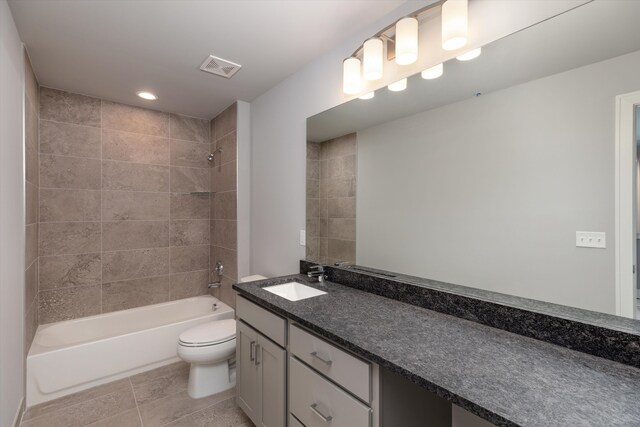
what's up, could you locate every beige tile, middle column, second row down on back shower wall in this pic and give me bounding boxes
[102,129,169,165]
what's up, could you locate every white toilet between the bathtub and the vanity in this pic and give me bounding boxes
[178,275,266,399]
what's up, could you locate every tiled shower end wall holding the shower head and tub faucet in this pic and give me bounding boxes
[211,103,238,307]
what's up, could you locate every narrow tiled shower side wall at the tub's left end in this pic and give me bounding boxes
[24,51,40,356]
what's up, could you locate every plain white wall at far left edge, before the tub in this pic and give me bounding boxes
[0,0,25,427]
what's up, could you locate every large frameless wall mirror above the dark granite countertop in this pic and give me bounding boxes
[307,1,640,320]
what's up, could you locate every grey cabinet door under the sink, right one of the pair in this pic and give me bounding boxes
[256,335,287,427]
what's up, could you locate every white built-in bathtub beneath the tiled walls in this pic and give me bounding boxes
[27,296,235,406]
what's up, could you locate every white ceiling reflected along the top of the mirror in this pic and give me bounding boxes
[307,0,640,141]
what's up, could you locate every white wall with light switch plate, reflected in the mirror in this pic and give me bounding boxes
[356,51,640,314]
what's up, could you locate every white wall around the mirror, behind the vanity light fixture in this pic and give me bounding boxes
[251,0,584,276]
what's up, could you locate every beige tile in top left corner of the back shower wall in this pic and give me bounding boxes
[40,87,100,126]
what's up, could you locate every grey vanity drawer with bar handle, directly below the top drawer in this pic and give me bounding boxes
[289,357,371,427]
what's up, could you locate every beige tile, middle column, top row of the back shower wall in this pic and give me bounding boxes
[102,101,169,137]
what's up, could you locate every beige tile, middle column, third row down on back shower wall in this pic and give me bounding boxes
[102,160,169,191]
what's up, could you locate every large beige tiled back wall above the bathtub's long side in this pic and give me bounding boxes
[38,88,211,324]
